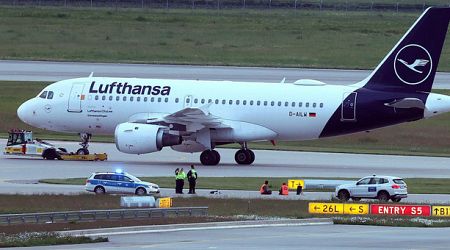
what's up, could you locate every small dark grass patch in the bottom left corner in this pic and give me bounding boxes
[0,232,108,248]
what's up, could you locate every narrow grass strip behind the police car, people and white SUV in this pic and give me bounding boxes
[40,177,450,194]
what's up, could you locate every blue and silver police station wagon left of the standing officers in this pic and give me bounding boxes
[85,171,159,195]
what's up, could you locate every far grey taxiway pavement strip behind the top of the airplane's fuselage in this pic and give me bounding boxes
[0,60,450,89]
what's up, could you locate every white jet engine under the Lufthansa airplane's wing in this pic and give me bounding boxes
[114,122,181,154]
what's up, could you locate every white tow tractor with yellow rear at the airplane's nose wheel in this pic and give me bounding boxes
[3,129,108,161]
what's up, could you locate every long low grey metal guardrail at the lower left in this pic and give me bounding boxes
[0,207,208,225]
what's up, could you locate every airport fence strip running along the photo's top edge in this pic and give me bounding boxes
[0,0,450,12]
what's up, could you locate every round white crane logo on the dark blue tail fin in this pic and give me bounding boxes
[394,44,433,85]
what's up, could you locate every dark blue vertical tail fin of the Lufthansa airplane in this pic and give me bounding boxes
[360,7,450,92]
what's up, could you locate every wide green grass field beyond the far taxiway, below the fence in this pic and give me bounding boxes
[0,7,450,71]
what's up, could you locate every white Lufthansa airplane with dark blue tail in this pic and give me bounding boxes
[17,7,450,165]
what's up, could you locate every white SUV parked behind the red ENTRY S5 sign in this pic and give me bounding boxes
[335,175,408,202]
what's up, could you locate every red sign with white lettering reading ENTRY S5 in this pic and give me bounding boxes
[370,204,431,216]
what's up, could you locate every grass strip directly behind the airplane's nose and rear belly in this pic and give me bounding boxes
[0,81,450,157]
